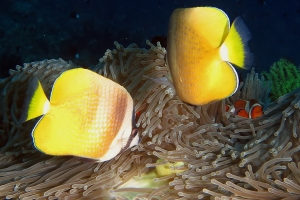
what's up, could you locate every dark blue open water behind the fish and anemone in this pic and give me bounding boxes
[0,0,300,78]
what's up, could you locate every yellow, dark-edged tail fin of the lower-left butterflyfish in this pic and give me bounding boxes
[20,77,50,123]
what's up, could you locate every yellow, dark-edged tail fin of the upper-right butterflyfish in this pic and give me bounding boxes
[220,17,253,69]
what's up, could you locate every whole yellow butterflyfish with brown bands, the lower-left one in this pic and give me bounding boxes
[20,68,139,161]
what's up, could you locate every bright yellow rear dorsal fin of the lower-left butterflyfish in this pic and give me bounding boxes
[50,68,93,104]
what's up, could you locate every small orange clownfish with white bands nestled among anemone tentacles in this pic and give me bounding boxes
[226,99,264,119]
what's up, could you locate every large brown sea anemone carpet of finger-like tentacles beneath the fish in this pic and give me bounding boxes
[0,41,300,200]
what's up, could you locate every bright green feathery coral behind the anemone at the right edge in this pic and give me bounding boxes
[261,58,300,100]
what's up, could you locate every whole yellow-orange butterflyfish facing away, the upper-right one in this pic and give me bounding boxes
[167,7,253,105]
